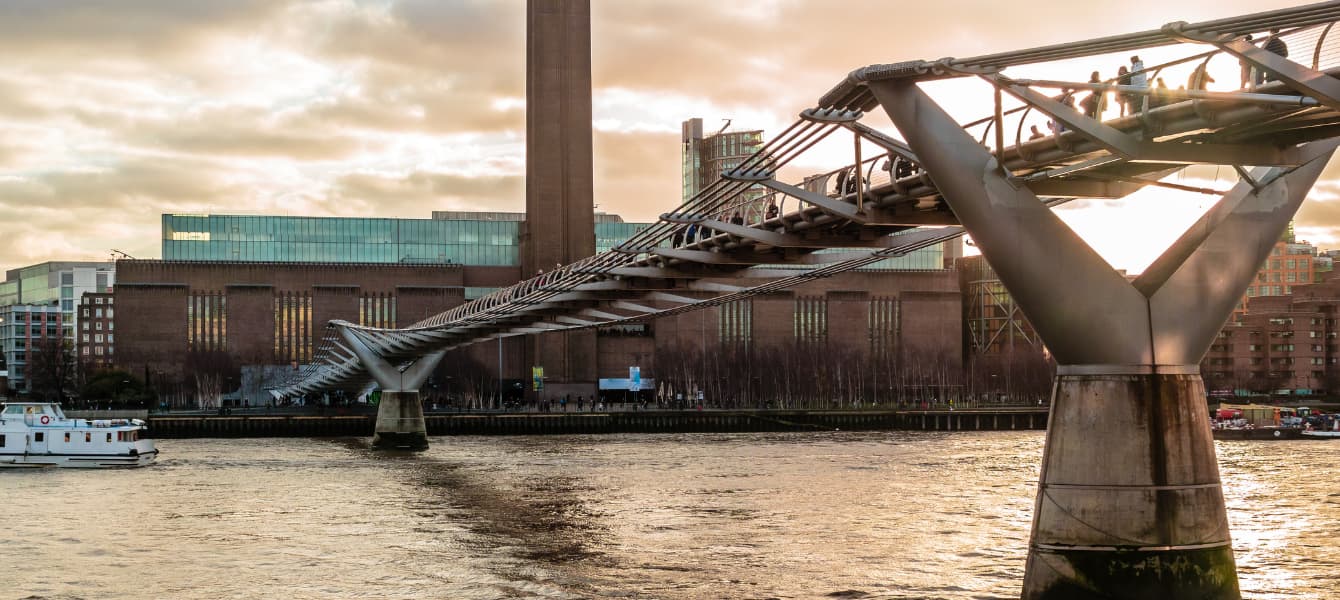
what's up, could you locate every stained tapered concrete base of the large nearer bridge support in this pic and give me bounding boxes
[1022,367,1241,600]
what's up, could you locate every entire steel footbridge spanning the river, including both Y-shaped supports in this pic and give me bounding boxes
[275,3,1340,599]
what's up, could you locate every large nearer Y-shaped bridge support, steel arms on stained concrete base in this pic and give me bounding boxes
[868,80,1337,600]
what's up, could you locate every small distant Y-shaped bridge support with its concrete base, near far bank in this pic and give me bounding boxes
[339,327,446,450]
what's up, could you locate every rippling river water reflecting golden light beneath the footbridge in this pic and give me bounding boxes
[0,431,1340,599]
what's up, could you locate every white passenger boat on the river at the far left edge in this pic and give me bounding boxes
[0,402,158,469]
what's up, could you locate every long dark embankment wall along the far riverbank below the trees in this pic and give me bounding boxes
[149,407,1047,439]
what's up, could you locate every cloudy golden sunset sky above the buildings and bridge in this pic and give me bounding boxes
[0,0,1340,271]
